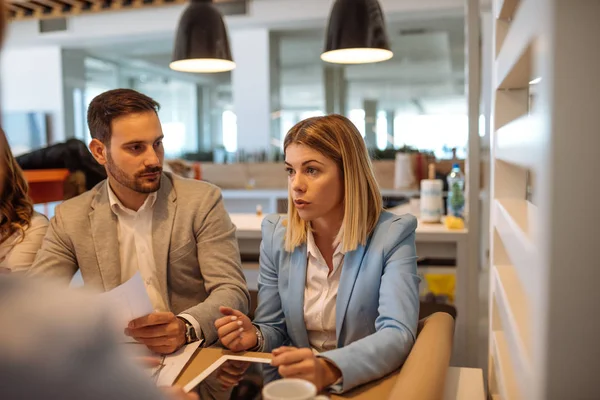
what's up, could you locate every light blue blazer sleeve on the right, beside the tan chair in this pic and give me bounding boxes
[321,215,420,392]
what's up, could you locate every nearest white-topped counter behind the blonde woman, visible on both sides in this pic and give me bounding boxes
[230,214,479,366]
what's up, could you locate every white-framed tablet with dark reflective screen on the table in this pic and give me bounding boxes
[184,355,278,400]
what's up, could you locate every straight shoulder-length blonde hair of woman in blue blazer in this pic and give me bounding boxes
[283,114,383,252]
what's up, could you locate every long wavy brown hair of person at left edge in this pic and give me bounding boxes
[0,129,33,244]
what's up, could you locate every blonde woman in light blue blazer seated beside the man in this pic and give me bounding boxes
[215,115,420,392]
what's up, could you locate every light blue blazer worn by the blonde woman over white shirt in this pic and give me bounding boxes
[254,211,420,391]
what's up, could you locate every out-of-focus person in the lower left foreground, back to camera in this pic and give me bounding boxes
[0,0,198,400]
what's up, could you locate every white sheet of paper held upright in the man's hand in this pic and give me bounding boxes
[99,272,154,342]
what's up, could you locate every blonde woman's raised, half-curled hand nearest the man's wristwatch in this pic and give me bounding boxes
[215,307,258,351]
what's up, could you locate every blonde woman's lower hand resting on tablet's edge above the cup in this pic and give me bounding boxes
[271,346,342,392]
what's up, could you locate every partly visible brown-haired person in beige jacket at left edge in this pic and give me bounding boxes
[0,129,48,272]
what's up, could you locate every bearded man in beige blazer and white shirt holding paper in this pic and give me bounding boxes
[29,89,249,354]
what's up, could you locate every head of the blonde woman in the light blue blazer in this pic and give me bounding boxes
[283,115,382,252]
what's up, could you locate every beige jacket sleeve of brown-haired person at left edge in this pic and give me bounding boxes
[0,212,49,273]
